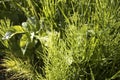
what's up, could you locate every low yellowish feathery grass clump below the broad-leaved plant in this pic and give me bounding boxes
[2,56,34,80]
